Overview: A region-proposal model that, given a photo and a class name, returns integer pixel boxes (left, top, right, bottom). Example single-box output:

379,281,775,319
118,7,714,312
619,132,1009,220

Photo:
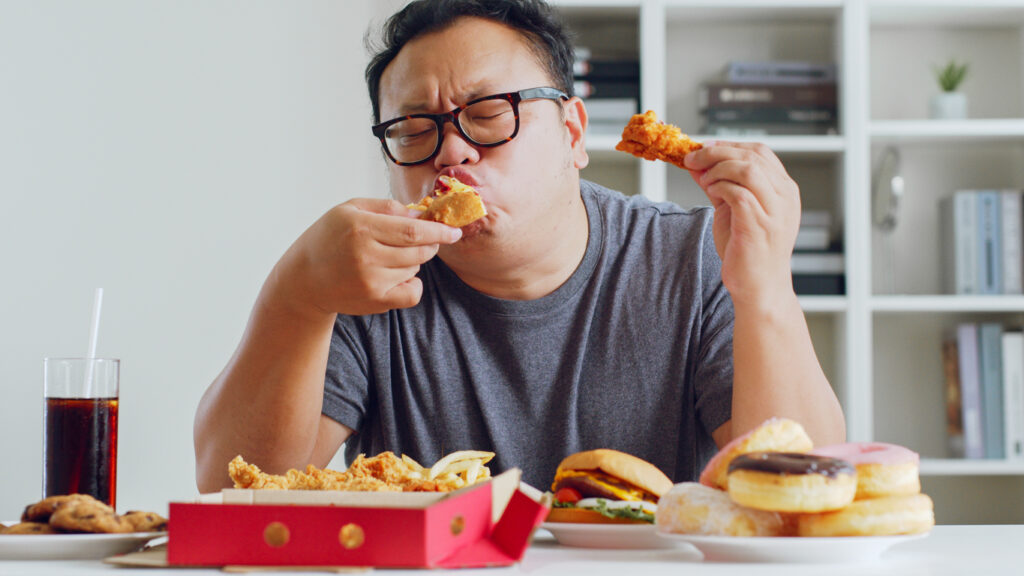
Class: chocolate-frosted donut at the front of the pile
729,452,857,512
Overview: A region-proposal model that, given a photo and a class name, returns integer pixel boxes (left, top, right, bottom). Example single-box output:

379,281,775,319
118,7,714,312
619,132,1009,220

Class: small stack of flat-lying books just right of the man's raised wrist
791,210,846,295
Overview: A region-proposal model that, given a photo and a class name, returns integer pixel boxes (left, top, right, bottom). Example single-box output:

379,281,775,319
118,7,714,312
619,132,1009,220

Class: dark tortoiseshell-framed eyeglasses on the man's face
373,87,569,166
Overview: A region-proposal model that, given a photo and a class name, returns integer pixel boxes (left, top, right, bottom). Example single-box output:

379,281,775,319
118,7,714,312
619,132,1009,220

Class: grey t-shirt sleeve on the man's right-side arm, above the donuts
695,213,735,435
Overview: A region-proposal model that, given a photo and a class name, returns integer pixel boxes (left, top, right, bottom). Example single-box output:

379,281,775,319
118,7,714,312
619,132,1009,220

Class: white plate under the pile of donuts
657,532,928,563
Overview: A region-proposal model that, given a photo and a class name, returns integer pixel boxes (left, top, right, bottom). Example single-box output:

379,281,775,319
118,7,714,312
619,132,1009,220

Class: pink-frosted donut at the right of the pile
811,442,921,500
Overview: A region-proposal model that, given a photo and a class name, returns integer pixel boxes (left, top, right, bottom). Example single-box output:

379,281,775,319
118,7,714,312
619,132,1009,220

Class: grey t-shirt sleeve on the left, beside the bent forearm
322,315,370,430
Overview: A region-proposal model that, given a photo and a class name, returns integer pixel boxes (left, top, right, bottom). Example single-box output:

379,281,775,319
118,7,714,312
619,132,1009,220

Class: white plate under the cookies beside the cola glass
0,532,167,561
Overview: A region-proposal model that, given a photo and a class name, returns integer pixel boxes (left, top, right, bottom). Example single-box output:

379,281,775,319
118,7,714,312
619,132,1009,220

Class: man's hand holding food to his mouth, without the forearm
272,199,462,315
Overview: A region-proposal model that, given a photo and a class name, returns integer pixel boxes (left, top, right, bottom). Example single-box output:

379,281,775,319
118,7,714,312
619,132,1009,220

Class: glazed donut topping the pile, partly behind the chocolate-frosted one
700,418,814,490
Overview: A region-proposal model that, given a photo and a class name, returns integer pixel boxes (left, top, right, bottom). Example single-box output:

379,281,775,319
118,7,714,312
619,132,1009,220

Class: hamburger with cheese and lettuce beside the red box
548,449,672,524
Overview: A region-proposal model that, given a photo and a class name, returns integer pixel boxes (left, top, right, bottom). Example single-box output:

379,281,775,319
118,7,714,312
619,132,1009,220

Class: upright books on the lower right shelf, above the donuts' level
942,322,1024,460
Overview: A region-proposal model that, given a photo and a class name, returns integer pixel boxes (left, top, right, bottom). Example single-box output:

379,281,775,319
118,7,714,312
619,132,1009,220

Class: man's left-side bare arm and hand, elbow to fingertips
195,199,462,492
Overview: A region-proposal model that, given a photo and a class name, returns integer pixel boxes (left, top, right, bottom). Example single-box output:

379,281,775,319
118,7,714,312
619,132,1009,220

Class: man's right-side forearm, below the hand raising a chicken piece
732,294,846,445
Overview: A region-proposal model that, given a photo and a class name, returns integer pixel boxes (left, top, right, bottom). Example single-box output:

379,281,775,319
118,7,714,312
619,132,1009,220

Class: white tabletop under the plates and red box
0,525,1024,576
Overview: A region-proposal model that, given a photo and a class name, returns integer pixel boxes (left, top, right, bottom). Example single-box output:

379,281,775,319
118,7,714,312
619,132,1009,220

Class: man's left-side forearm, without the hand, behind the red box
194,276,334,492
